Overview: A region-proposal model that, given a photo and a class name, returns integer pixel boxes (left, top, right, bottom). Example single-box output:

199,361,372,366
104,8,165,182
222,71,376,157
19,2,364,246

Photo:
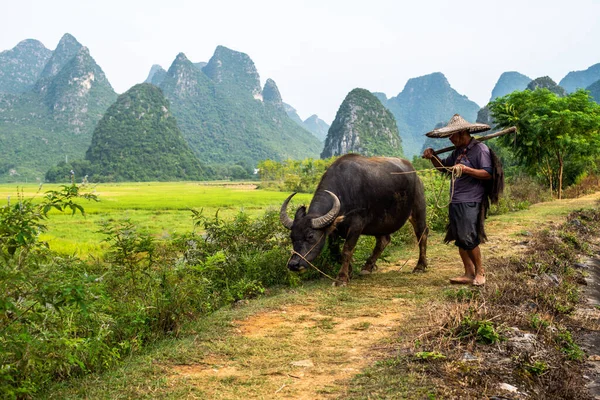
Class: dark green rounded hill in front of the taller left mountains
85,83,204,182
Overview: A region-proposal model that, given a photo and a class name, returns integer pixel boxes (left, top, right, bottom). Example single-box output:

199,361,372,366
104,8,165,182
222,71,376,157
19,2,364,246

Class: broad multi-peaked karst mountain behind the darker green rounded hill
159,46,321,167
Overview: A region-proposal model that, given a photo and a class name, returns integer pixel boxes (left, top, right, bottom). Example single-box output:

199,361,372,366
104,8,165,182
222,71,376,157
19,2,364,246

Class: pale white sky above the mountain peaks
0,0,600,124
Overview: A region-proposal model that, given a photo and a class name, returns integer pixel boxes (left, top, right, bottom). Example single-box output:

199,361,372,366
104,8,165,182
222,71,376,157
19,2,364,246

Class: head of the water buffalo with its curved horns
279,190,340,271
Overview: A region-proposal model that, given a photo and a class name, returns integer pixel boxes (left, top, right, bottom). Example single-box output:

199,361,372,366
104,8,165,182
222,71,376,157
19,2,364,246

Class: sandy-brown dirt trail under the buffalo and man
168,193,600,399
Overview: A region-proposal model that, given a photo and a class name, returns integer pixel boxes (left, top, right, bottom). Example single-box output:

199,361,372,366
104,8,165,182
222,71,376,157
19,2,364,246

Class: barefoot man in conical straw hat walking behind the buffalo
423,114,493,286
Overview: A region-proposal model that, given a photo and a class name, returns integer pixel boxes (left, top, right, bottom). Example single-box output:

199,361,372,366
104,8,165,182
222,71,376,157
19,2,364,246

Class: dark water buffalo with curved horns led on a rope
279,154,428,285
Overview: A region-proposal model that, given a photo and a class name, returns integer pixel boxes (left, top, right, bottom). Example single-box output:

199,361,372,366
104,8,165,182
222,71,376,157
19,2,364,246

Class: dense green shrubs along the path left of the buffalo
0,192,296,398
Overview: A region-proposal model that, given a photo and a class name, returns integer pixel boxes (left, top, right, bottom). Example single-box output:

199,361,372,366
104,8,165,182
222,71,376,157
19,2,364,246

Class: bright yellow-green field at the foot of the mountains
0,182,311,257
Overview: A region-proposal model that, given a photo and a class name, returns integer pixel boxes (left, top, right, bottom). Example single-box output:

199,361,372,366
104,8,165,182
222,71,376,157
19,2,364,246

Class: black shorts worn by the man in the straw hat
447,202,481,250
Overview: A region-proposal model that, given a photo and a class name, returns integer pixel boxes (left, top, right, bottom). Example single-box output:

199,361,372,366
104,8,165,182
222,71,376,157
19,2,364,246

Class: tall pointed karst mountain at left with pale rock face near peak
0,34,117,181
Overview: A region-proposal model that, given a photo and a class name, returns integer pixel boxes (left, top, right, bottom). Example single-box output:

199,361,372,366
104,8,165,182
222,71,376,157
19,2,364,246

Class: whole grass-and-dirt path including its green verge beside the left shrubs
43,193,600,400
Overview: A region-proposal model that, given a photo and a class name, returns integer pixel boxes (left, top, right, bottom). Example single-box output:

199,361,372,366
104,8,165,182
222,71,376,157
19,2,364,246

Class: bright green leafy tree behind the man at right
490,89,600,199
